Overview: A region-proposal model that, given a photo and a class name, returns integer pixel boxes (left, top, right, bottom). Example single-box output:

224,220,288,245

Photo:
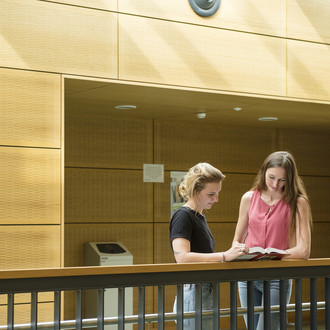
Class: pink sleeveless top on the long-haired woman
245,190,290,250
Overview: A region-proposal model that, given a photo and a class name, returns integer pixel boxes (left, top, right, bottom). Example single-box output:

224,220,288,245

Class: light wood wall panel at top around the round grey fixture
118,0,286,36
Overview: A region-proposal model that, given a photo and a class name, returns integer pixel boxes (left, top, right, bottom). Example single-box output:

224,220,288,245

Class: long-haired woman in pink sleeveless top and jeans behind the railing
233,151,312,330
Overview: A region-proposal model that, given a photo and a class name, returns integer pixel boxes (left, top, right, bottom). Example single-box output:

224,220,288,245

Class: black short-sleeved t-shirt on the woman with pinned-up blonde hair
170,206,215,253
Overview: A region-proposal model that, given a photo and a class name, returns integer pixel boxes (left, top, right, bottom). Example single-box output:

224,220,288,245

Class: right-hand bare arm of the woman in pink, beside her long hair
286,197,311,259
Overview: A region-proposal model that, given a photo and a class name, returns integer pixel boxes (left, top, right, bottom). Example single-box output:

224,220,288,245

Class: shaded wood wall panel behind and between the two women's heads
154,172,255,222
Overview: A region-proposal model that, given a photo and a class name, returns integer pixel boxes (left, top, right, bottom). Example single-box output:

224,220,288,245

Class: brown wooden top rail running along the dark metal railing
0,258,330,280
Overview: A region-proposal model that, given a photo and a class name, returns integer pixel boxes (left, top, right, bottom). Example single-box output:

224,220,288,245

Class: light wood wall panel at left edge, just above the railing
0,226,61,269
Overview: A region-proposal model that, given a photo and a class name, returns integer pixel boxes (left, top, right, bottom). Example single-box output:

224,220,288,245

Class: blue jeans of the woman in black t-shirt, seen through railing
173,283,213,330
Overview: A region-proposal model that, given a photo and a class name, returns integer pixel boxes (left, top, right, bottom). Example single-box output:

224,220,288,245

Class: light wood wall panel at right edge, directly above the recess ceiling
287,40,330,101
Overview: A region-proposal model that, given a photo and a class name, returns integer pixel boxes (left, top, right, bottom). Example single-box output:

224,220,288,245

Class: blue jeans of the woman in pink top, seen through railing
238,280,292,330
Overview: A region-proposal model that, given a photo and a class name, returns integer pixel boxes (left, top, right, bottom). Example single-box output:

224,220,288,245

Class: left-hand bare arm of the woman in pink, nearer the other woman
233,191,253,244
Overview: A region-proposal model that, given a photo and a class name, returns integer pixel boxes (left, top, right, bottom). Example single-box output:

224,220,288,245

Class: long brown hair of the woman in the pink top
252,151,312,231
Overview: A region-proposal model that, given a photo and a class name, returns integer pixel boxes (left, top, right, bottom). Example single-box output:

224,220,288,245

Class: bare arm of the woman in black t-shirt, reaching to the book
172,238,247,263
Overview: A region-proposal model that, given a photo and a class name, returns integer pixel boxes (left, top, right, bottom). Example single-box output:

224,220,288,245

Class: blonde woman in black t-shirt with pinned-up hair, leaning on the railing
170,163,248,330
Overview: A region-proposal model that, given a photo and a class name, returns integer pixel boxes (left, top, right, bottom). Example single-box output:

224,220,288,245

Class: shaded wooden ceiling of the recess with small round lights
65,78,330,132
